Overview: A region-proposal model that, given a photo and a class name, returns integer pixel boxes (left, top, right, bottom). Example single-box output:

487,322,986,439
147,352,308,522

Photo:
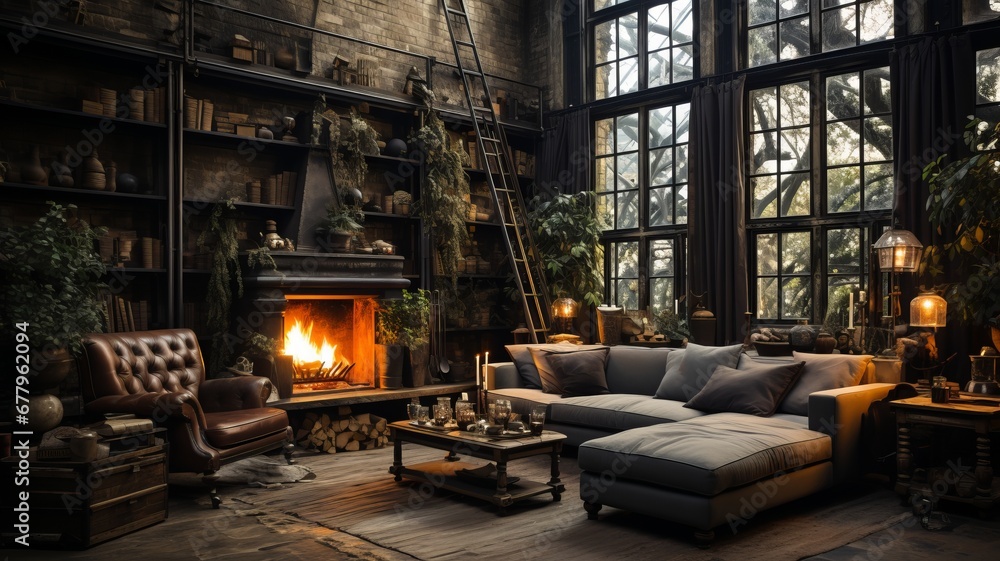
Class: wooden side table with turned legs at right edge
889,397,1000,515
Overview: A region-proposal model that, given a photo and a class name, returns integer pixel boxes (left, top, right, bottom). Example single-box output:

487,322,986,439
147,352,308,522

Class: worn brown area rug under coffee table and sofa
230,445,911,561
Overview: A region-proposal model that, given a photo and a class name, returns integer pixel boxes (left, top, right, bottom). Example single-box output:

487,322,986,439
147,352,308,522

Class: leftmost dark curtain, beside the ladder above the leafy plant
535,108,593,195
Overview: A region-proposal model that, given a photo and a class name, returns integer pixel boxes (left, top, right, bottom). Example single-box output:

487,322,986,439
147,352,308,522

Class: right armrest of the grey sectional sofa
809,384,896,482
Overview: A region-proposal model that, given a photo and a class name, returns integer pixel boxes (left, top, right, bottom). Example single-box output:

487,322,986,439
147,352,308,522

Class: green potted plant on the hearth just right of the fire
375,289,430,387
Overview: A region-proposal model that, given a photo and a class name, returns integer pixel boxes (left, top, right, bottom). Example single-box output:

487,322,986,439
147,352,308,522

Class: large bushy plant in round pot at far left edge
0,201,107,431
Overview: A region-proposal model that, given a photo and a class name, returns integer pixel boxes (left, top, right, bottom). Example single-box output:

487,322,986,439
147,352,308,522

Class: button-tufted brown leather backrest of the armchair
81,329,205,402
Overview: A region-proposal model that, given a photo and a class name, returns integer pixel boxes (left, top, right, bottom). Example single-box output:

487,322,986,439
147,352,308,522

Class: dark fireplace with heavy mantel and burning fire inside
244,252,410,399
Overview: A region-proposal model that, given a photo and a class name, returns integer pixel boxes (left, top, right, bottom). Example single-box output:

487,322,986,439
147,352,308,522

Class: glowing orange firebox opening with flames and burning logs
282,295,375,393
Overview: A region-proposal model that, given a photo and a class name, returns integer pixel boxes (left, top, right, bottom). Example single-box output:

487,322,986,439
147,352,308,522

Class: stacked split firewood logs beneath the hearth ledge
295,406,389,454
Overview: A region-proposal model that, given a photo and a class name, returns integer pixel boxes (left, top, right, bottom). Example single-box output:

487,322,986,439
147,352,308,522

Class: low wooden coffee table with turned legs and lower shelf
389,421,566,515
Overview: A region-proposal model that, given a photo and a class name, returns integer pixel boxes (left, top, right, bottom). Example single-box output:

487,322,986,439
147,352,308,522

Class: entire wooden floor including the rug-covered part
8,444,1000,561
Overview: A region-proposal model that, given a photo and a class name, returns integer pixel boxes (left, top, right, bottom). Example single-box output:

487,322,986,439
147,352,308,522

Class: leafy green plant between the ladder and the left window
528,192,604,306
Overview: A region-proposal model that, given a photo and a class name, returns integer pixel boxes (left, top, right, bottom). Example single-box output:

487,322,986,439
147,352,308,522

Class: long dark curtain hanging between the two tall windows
687,77,749,344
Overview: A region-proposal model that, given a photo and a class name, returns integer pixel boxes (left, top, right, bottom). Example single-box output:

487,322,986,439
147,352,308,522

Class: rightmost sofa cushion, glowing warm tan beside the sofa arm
778,351,872,415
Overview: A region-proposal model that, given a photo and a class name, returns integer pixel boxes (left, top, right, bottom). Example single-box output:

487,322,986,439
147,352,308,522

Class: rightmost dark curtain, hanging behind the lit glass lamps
890,35,979,382
